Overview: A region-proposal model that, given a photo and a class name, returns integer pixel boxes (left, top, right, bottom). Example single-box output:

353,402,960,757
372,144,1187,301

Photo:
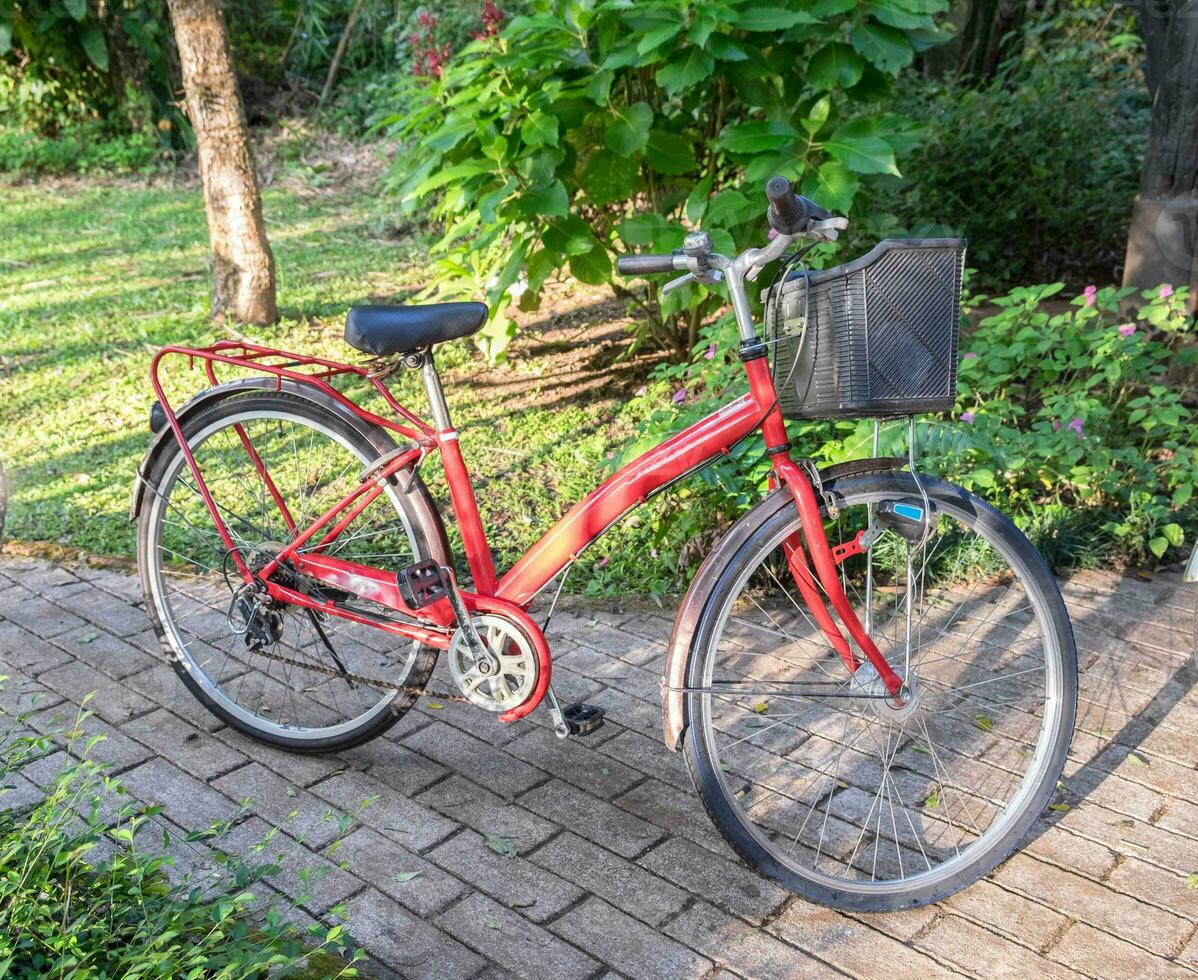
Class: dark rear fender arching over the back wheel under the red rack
129,377,450,563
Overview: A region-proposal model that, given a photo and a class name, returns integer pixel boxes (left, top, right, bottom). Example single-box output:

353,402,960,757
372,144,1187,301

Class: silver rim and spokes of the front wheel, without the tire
691,491,1065,899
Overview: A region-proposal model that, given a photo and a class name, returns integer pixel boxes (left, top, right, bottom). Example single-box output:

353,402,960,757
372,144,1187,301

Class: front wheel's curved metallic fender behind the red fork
661,456,906,752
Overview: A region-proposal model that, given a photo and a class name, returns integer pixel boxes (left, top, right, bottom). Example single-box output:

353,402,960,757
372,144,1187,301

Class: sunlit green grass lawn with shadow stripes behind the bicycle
0,182,683,592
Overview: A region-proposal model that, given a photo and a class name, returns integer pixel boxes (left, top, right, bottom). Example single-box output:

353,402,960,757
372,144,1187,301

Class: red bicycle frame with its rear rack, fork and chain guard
151,333,902,721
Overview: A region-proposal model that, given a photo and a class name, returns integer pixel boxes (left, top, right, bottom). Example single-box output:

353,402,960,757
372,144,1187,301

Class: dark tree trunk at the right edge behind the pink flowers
1124,0,1198,311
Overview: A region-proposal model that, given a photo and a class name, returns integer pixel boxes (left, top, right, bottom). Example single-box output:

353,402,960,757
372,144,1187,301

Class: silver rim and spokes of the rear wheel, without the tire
146,409,420,742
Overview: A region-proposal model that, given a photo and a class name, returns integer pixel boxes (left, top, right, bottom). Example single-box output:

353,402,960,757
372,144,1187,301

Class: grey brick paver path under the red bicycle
0,559,1198,980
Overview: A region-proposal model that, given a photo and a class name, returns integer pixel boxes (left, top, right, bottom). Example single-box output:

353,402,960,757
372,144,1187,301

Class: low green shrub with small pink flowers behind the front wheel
613,283,1198,577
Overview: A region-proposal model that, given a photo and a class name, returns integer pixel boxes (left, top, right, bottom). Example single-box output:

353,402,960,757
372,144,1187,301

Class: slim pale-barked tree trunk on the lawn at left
168,0,278,323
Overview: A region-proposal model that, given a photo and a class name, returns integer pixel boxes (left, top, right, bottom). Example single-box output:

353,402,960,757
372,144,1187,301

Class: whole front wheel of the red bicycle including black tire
684,473,1077,912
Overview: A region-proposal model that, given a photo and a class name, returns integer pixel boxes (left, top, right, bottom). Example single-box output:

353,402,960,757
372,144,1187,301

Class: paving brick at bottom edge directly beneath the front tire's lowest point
769,901,952,978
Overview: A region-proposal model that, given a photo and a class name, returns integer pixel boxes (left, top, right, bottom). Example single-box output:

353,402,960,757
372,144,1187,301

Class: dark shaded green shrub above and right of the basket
858,7,1151,289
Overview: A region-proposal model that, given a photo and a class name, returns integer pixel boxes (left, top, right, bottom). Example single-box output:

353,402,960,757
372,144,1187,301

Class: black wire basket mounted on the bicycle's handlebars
766,238,966,418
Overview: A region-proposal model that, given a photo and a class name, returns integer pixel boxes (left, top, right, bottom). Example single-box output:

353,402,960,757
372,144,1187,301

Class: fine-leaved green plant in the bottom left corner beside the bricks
0,690,361,980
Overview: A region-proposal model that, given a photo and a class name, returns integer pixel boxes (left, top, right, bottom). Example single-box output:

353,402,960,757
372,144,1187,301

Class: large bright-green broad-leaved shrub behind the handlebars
382,0,946,357
